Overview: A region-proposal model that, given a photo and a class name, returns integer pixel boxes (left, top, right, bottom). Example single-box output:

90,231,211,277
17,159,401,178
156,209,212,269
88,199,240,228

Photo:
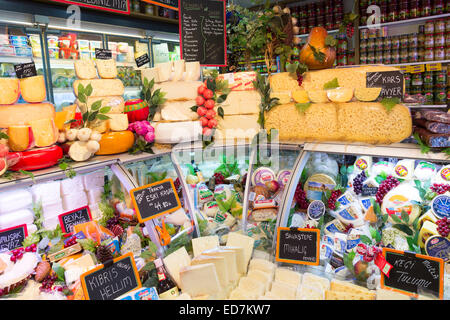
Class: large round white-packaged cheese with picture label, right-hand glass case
381,183,422,225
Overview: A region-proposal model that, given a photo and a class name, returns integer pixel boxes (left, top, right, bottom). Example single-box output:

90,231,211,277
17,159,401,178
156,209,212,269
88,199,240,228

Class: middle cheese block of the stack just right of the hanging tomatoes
215,90,261,116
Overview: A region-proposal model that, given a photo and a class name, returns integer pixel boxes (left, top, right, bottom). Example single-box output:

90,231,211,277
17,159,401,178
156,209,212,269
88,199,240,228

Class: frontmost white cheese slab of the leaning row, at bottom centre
180,263,222,299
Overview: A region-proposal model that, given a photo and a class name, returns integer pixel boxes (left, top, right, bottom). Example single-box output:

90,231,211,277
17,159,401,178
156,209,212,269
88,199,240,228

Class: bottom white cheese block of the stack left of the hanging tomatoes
152,121,202,144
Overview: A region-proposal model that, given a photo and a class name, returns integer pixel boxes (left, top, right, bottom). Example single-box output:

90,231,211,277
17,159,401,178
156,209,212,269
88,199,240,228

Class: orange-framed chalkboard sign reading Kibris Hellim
80,252,142,300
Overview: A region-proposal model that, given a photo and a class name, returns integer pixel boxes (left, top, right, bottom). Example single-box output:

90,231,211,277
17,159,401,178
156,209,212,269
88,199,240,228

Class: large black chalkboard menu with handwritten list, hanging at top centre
179,0,227,67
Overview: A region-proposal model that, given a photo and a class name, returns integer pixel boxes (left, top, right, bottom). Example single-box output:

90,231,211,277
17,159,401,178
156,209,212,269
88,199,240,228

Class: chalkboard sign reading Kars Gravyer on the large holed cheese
366,71,404,99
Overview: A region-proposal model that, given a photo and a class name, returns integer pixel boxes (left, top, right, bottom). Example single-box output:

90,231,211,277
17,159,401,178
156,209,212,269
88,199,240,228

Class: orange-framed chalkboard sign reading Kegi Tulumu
380,248,444,299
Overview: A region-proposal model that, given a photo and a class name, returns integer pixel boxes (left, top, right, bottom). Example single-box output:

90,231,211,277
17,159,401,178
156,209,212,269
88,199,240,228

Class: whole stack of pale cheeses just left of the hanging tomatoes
141,60,202,144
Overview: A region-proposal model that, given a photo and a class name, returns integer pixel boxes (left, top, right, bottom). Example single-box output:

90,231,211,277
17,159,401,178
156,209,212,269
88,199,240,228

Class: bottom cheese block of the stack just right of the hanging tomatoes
215,114,261,141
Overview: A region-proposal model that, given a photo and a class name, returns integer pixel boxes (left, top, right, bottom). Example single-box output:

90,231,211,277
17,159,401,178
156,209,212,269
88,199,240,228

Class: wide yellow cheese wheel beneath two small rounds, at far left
0,103,55,128
